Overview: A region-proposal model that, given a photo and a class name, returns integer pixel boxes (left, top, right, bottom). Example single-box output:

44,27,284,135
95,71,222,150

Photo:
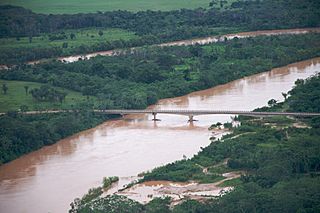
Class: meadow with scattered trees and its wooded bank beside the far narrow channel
0,28,139,64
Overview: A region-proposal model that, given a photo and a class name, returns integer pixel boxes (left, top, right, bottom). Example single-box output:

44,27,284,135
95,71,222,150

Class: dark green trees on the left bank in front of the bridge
0,110,113,165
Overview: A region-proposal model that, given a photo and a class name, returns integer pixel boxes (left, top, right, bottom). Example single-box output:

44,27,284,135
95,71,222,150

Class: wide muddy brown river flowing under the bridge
0,58,320,213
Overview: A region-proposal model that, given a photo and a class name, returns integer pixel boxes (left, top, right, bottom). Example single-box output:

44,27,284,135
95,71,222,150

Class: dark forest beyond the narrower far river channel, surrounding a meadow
0,0,320,64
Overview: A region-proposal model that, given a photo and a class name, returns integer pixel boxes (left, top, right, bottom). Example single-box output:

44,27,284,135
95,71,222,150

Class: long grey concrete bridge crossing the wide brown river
0,109,320,122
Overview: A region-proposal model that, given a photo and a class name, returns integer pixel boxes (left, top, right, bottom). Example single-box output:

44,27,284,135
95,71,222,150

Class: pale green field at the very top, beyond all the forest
0,0,211,14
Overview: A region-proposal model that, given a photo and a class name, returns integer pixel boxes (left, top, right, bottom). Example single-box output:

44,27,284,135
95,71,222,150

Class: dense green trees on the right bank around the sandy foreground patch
70,75,320,213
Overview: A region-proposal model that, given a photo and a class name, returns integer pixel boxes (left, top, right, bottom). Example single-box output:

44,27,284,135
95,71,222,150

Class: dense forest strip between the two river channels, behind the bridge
0,34,320,109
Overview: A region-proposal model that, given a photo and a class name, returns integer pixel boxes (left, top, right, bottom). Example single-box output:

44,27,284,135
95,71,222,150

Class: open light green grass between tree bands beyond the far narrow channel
0,28,138,53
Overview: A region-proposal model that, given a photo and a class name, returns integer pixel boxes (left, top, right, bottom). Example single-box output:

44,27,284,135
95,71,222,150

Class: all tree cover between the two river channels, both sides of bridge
0,34,320,163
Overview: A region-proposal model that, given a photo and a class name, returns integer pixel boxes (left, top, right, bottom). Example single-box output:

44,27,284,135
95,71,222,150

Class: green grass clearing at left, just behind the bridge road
0,80,96,112
